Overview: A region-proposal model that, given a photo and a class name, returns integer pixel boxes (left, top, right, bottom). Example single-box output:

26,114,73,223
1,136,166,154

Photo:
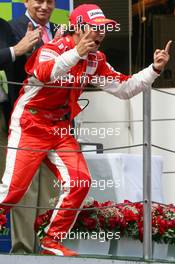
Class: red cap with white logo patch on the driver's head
70,4,118,26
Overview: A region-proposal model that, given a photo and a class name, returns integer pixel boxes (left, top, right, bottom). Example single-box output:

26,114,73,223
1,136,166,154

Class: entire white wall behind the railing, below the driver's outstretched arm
77,89,175,204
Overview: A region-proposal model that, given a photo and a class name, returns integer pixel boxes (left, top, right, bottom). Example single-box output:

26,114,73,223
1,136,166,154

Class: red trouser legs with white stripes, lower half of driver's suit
0,113,90,238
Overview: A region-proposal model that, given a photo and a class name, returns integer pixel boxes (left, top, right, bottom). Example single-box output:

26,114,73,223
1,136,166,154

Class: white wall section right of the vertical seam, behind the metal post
130,88,175,204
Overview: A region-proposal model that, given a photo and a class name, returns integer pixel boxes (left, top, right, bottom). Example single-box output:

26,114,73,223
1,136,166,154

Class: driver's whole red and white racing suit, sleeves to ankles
0,35,158,239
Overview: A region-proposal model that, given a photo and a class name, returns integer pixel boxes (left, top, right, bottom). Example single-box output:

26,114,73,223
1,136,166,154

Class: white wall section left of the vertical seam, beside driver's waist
77,91,129,153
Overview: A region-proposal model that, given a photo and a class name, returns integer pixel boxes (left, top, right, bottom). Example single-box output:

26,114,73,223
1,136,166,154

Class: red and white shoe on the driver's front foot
40,236,78,257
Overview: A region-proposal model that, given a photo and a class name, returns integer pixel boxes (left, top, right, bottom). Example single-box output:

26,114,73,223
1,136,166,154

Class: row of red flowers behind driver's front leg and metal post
35,198,175,244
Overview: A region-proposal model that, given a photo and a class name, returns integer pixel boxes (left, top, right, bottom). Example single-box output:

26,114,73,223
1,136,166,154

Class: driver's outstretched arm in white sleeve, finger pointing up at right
97,41,172,99
